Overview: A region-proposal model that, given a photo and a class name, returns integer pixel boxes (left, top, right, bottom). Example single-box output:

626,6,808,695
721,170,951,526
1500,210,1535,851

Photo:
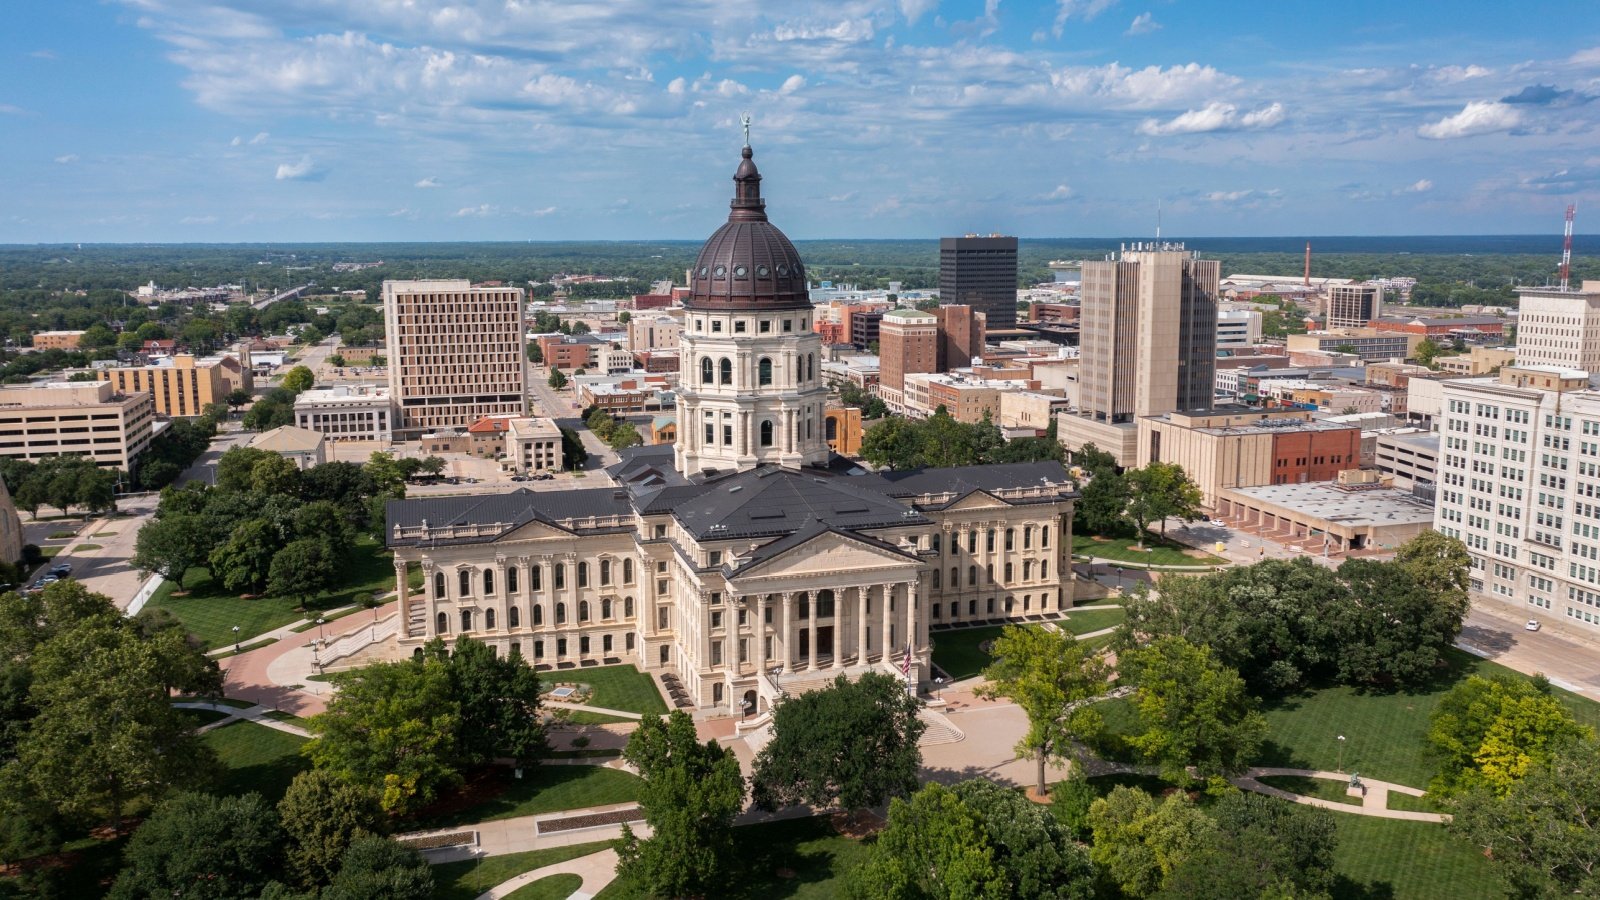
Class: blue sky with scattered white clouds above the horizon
0,0,1600,243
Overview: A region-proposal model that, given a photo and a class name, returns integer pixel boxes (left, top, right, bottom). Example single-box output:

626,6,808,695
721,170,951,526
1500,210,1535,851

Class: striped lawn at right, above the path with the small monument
1258,650,1600,788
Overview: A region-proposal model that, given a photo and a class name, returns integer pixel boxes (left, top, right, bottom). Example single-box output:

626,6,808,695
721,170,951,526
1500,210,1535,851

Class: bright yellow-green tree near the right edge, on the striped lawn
1427,674,1594,796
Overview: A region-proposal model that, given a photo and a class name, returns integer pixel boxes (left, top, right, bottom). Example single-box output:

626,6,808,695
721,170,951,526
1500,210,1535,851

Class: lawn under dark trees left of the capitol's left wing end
150,535,395,649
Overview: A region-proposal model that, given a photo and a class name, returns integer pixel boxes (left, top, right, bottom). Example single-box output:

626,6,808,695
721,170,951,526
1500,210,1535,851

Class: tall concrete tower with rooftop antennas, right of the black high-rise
1059,243,1221,466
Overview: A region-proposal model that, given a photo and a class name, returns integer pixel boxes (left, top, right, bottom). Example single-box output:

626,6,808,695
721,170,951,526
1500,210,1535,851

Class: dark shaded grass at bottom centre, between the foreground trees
595,817,869,900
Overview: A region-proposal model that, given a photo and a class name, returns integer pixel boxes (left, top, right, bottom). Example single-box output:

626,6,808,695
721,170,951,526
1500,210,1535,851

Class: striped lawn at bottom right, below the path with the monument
1333,814,1506,900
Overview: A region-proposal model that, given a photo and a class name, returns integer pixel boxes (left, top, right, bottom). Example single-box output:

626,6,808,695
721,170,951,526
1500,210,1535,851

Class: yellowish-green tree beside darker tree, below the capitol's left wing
302,650,461,814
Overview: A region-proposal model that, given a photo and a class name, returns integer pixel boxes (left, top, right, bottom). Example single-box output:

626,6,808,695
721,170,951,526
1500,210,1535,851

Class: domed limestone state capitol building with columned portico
386,146,1075,713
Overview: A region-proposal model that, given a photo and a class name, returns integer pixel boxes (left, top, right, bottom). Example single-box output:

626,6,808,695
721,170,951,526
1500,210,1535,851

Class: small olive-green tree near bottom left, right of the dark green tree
278,769,389,889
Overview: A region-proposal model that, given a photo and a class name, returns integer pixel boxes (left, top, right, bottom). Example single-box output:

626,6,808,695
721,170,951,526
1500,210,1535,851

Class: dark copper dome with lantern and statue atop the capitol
683,147,811,311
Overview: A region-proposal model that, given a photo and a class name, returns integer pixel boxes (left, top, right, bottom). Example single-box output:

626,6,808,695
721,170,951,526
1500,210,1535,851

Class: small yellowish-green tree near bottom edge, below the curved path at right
1090,786,1216,897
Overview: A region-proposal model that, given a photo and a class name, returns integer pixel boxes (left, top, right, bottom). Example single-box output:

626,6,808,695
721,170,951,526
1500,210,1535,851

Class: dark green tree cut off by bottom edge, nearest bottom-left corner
110,793,282,900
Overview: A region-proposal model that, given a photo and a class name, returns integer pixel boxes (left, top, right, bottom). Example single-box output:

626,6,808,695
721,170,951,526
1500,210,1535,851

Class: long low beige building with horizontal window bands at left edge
0,381,155,472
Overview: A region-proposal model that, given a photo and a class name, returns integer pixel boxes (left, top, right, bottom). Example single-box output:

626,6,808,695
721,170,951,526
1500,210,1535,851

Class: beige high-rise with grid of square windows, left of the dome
384,280,528,439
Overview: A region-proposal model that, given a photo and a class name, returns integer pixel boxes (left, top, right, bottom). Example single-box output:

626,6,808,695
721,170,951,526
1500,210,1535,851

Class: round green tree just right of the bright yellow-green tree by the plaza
1118,637,1267,785
